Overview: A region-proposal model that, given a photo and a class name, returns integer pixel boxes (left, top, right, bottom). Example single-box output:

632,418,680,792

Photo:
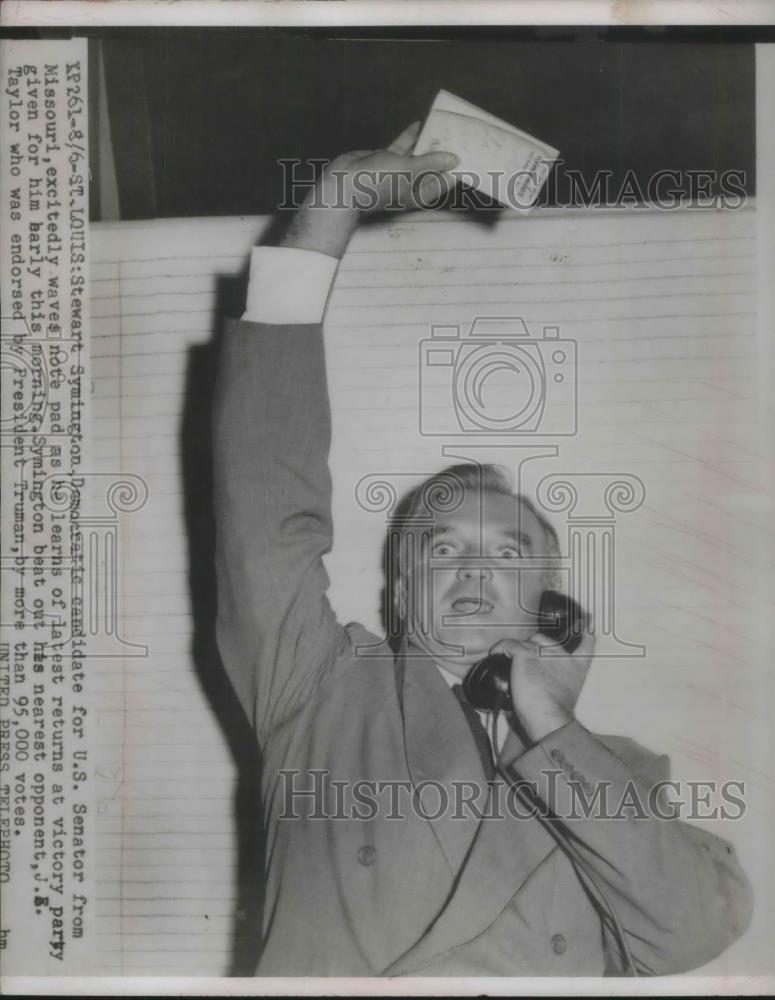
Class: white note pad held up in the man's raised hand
413,90,559,211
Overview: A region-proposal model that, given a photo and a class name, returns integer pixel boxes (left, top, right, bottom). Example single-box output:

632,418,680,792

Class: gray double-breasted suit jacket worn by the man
214,322,751,976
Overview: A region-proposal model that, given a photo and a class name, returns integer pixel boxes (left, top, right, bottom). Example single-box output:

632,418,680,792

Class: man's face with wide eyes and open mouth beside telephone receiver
407,490,550,677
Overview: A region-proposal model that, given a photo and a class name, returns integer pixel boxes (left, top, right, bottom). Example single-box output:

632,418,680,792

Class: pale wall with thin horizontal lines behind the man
91,209,775,975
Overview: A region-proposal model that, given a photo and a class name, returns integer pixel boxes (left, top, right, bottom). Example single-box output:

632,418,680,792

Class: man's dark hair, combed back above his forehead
383,462,560,633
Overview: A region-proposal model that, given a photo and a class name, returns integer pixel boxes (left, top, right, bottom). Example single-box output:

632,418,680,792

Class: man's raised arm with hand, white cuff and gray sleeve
213,130,453,742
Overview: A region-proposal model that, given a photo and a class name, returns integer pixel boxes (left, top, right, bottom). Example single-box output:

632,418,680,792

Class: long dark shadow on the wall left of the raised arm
180,262,264,976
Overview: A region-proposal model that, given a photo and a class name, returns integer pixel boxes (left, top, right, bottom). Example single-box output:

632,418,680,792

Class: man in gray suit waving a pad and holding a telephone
214,129,751,976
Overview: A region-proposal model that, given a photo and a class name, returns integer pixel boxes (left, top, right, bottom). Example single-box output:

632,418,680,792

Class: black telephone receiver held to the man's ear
463,590,587,712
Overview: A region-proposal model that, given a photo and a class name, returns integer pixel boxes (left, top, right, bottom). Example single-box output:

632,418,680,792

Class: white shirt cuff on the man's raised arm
242,247,339,324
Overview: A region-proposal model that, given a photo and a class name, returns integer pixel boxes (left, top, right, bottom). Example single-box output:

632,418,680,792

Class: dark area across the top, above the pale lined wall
94,29,755,218
